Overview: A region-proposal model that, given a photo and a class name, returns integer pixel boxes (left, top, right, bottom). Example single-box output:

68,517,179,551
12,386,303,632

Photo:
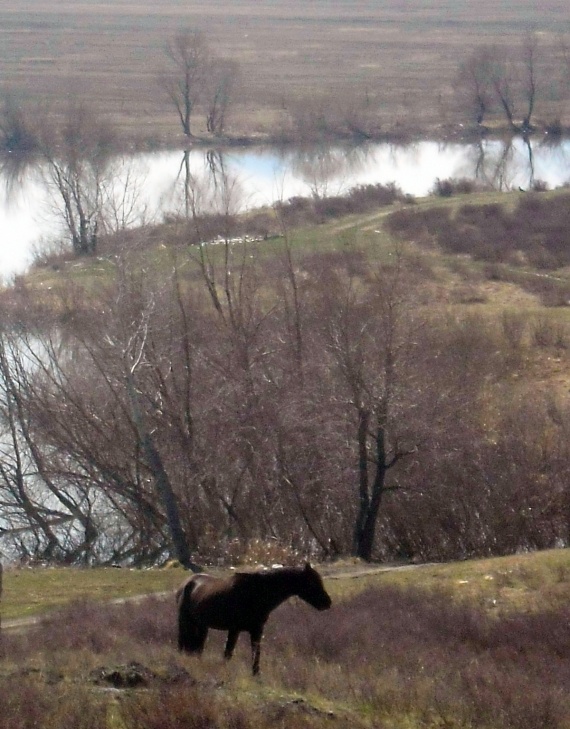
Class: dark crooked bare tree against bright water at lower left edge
0,332,98,562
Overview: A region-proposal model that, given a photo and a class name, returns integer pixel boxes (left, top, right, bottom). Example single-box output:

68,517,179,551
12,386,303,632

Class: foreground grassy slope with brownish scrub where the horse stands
0,550,570,729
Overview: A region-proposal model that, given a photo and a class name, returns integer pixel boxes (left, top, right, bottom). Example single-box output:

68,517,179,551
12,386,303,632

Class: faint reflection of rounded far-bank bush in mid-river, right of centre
282,145,370,199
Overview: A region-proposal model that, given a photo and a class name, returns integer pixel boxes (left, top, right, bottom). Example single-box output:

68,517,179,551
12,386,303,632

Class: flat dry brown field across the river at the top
0,0,570,142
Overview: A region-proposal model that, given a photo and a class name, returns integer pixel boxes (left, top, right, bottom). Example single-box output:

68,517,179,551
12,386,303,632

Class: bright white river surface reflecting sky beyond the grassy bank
0,138,570,276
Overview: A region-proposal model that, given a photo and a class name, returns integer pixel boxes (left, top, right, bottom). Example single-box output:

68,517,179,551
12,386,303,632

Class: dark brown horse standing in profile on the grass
176,563,331,675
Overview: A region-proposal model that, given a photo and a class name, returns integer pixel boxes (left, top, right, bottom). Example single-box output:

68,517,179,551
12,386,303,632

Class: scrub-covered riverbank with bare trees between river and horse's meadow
0,183,570,566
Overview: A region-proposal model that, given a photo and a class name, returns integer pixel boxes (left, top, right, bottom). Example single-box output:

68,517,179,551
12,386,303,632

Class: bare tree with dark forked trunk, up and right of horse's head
316,247,417,560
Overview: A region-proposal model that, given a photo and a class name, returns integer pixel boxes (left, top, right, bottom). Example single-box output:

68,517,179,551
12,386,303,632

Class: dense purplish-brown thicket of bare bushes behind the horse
0,237,570,563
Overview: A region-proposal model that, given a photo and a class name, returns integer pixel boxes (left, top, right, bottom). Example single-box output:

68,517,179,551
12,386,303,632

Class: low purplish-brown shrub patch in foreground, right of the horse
268,588,570,729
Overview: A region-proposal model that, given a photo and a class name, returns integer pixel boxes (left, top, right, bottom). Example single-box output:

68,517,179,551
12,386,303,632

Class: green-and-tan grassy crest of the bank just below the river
19,185,570,328
